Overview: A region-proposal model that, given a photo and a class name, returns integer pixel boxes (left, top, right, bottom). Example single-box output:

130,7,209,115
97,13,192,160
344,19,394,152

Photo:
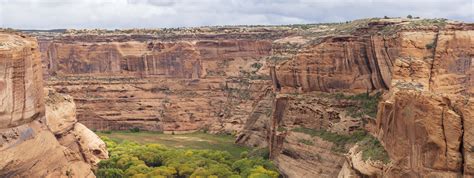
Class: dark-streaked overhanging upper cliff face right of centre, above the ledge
277,36,399,92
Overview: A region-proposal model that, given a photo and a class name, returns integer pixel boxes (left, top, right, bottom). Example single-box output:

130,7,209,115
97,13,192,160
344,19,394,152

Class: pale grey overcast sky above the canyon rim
0,0,474,29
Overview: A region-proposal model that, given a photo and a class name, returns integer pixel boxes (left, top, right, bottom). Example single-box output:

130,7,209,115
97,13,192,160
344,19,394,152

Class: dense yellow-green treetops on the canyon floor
96,137,279,178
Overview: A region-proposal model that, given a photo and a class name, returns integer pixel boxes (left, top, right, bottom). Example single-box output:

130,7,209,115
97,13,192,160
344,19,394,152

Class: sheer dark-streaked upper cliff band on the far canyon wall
42,40,271,78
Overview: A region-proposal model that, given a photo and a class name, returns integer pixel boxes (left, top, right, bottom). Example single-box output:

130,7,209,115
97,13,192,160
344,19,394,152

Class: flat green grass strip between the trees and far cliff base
96,131,249,157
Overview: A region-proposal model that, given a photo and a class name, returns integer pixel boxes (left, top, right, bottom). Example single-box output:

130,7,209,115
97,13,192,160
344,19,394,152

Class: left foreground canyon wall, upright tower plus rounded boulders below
0,33,107,177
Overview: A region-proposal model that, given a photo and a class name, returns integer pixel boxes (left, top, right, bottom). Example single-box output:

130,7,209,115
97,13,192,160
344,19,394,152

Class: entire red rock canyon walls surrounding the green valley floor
0,19,474,177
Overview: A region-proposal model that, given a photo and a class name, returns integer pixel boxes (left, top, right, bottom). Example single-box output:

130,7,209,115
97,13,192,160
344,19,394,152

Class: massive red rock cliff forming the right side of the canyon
250,20,474,177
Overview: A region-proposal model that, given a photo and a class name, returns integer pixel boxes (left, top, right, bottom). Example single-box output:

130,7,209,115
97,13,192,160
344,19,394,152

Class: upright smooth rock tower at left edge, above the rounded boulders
0,34,44,129
